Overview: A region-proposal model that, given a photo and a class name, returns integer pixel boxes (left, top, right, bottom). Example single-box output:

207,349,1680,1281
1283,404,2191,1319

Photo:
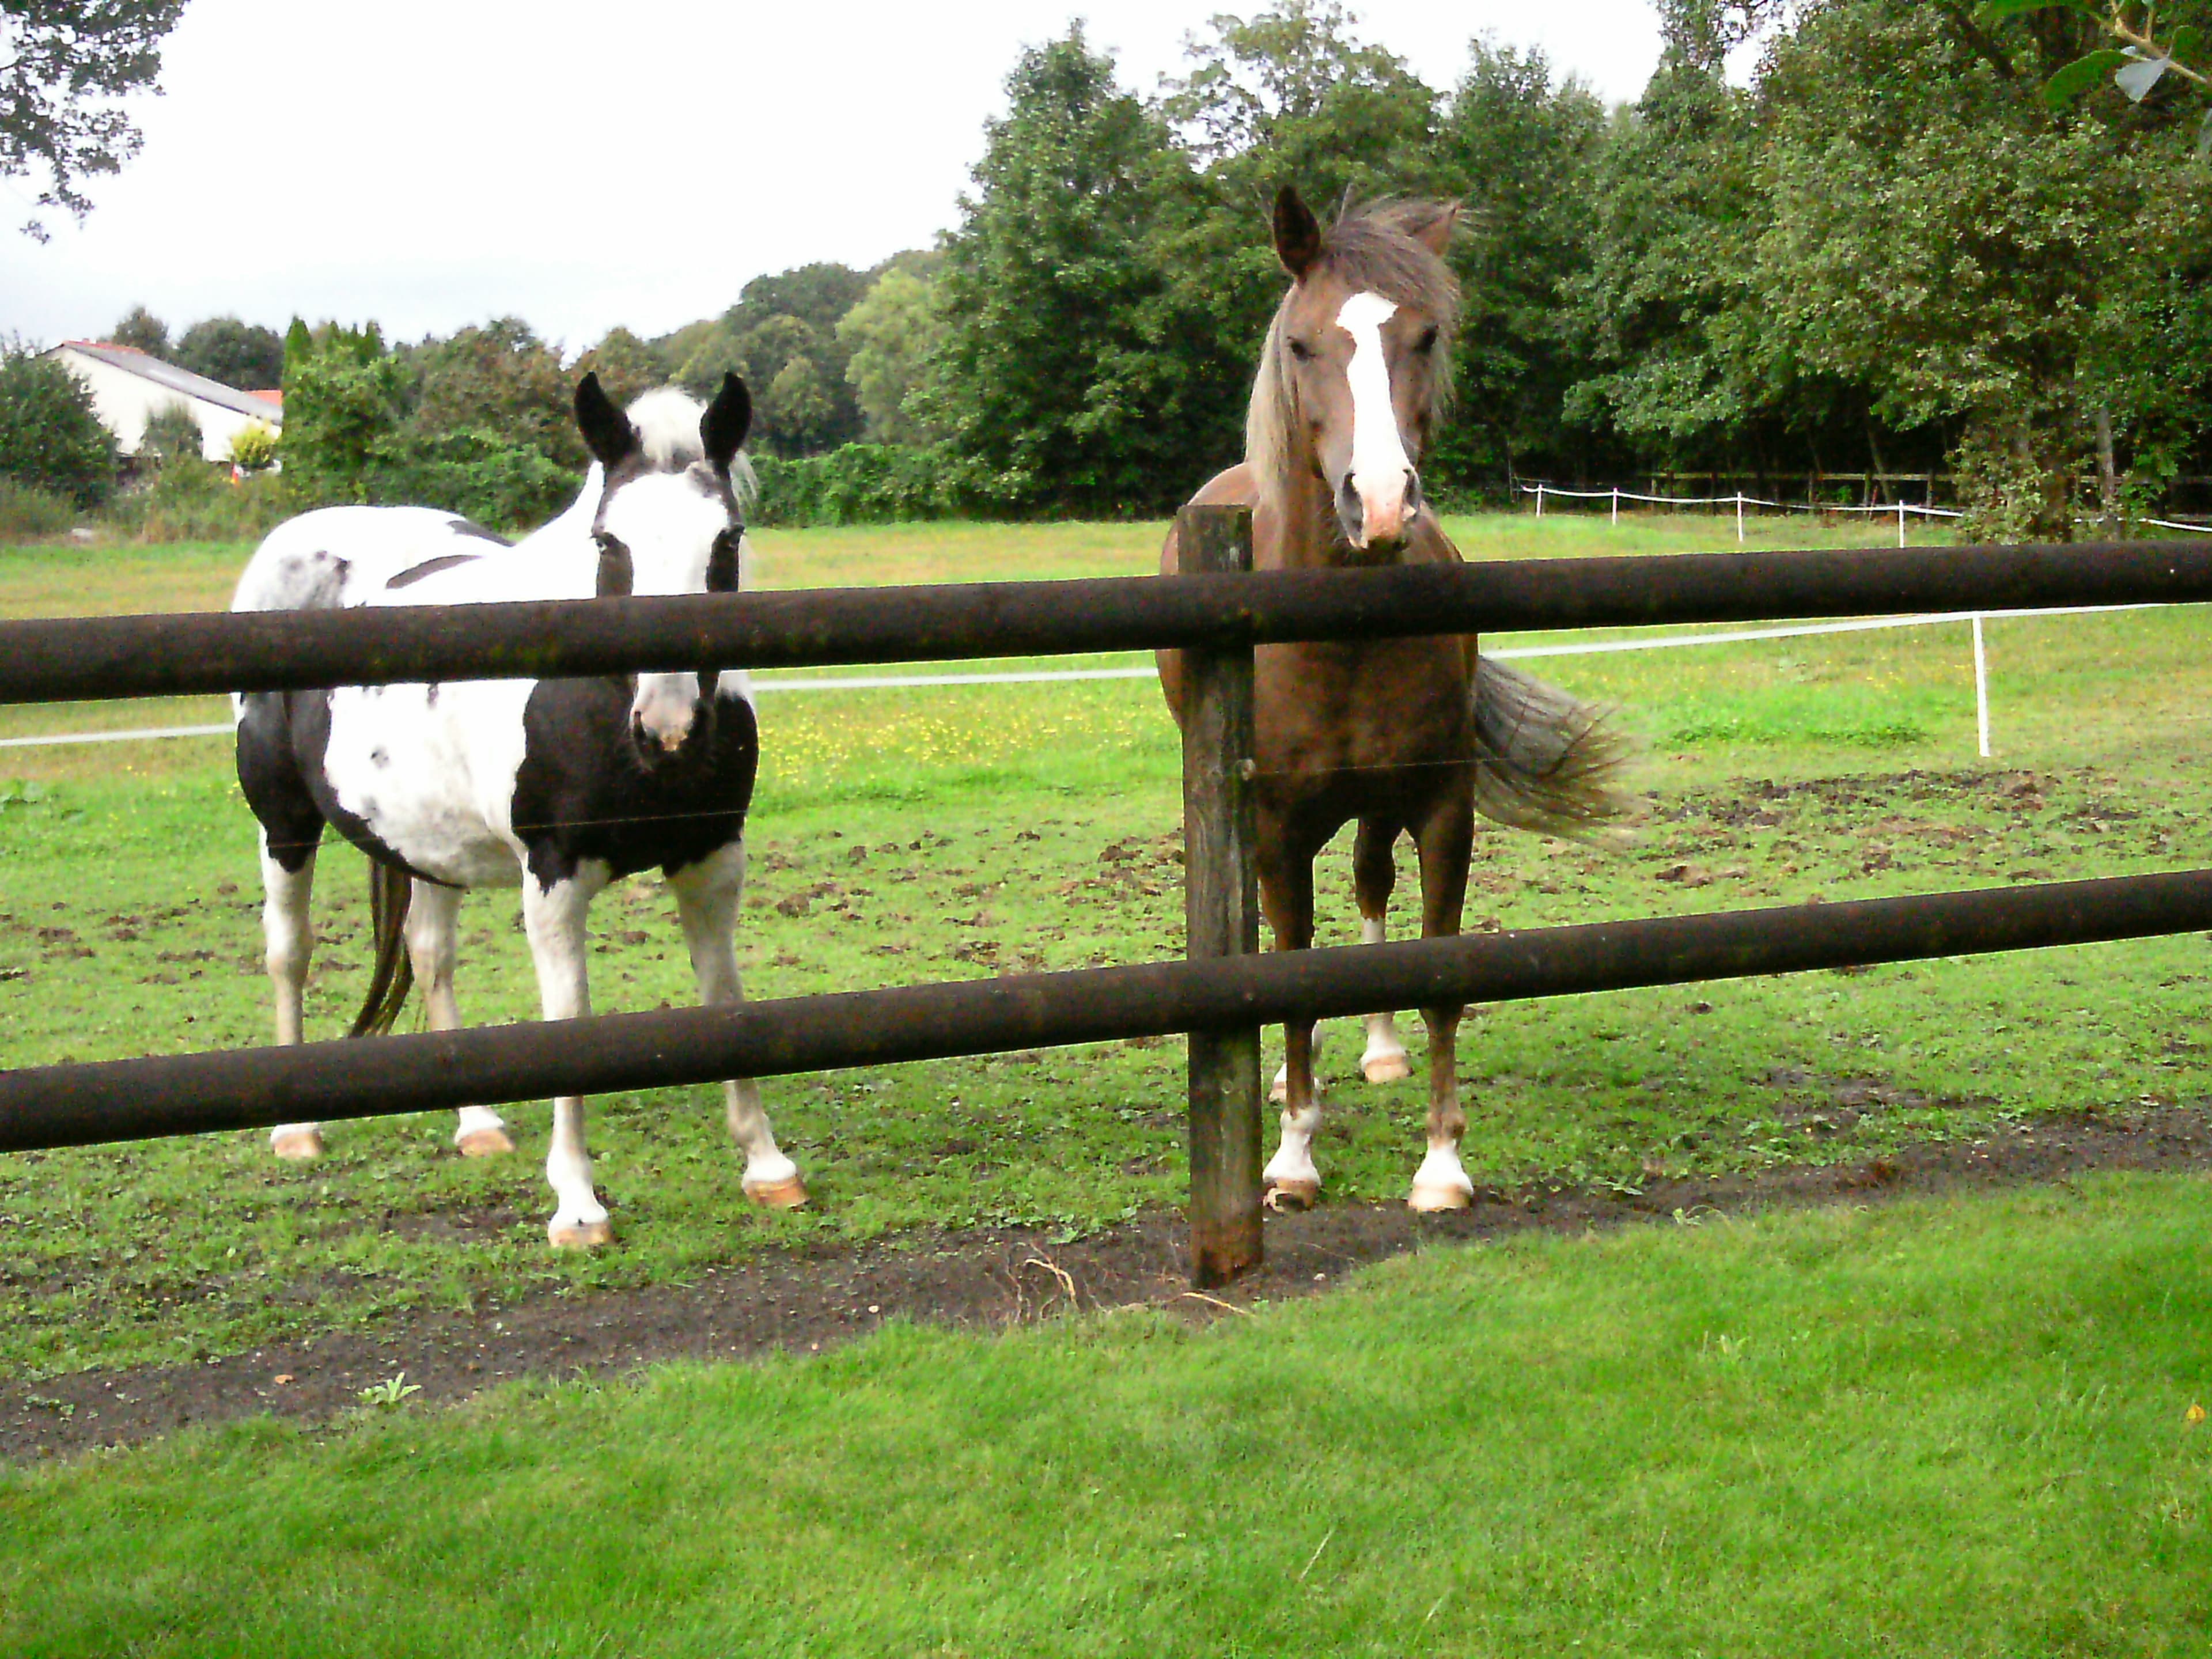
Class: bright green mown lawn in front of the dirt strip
0,1177,2212,1659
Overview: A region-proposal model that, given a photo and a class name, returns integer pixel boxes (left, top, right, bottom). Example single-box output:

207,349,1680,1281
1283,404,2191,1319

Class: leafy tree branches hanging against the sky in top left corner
0,0,184,241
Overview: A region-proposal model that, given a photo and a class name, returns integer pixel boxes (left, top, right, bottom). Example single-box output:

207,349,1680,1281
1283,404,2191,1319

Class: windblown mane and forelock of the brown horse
1245,201,1460,500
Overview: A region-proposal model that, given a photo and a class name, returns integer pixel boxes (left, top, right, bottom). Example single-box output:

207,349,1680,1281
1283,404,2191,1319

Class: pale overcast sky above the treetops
0,0,1659,352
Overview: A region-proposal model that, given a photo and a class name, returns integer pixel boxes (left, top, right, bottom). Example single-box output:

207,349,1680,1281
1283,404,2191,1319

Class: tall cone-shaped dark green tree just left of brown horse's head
922,24,1221,513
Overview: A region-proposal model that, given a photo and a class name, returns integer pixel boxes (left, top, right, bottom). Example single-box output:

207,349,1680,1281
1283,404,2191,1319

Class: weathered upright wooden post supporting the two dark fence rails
1175,506,1261,1287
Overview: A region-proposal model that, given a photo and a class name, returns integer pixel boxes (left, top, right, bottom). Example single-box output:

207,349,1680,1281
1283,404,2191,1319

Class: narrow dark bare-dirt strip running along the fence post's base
0,1106,2212,1460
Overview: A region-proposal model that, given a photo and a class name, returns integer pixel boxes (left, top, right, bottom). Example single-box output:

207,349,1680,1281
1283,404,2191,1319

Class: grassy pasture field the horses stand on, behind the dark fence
0,518,2212,1378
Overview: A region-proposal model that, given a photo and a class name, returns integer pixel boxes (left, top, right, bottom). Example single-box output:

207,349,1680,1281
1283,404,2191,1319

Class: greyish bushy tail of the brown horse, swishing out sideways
1475,657,1643,840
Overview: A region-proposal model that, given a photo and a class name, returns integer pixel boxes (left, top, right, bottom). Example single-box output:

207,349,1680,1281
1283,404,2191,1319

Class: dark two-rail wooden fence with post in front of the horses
0,528,2212,1283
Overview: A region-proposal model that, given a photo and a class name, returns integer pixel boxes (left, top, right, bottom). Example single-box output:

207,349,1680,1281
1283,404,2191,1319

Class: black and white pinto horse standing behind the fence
232,374,808,1248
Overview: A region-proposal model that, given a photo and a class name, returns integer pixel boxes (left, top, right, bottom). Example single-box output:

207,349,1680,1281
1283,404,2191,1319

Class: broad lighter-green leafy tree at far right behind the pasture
1754,0,2203,540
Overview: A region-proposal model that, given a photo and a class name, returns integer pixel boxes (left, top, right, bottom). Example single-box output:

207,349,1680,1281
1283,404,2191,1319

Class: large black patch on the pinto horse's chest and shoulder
513,679,761,889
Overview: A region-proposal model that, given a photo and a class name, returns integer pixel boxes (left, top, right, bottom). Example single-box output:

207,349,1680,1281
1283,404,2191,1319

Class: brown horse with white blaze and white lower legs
1159,188,1630,1210
